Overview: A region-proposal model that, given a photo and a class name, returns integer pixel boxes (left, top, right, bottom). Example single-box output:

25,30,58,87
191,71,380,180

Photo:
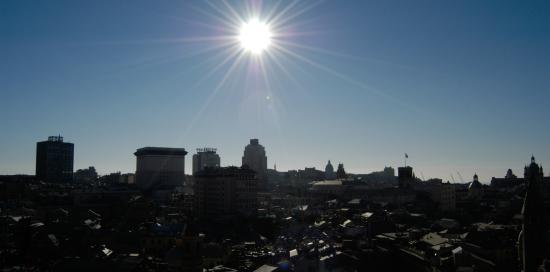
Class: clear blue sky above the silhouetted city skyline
0,0,550,182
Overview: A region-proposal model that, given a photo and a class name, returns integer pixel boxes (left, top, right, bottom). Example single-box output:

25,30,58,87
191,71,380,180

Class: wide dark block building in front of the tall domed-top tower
195,166,258,219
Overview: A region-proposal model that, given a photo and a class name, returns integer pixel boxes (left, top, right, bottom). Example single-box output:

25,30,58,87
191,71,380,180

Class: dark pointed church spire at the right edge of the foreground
518,157,548,272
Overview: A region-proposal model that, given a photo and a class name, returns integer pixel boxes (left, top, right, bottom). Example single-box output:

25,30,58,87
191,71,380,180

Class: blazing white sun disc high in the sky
239,19,272,54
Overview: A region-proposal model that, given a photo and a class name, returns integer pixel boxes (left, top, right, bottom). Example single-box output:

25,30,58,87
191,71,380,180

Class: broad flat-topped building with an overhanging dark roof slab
134,147,187,190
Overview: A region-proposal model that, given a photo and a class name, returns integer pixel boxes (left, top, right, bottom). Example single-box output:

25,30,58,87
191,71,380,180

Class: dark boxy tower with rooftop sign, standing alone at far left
36,136,74,182
